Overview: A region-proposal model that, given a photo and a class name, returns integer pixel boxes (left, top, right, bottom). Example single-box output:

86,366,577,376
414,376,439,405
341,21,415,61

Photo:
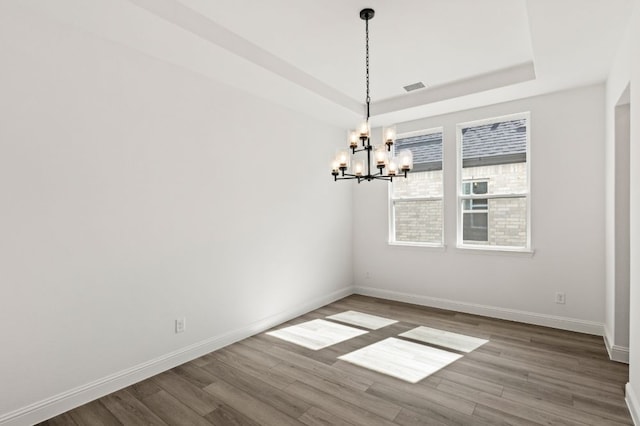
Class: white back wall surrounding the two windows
354,85,605,333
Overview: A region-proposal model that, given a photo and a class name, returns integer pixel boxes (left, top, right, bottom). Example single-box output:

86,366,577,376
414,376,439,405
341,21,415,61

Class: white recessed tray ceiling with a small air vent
10,0,633,127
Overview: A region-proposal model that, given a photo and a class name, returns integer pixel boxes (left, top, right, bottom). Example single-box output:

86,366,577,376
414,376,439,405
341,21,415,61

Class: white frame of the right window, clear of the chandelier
456,111,533,253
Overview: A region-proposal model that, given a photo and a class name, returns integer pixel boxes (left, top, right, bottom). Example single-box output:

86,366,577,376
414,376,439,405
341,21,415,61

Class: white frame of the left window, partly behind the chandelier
387,126,446,248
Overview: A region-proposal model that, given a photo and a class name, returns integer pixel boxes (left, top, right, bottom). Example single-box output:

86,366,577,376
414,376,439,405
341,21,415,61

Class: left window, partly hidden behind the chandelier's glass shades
389,129,443,246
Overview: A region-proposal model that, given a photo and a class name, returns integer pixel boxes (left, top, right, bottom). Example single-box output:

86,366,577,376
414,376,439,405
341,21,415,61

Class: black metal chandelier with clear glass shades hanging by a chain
331,9,413,183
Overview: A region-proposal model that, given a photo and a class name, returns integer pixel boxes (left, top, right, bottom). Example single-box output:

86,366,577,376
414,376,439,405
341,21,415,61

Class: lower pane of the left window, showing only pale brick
393,200,442,244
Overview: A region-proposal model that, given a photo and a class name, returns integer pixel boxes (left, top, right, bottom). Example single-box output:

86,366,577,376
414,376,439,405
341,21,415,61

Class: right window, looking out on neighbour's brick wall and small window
458,113,530,249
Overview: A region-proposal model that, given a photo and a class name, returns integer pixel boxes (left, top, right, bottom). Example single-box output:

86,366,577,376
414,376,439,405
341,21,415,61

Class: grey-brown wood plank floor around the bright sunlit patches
37,296,633,426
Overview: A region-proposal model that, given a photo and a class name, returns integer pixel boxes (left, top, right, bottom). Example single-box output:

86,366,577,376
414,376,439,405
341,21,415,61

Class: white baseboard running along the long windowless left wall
0,287,353,426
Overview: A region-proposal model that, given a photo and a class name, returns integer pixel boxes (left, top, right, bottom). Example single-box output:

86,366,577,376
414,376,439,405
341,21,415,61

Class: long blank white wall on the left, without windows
0,8,353,424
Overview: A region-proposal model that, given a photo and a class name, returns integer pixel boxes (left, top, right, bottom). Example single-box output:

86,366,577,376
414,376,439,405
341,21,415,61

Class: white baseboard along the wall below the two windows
354,287,604,336
